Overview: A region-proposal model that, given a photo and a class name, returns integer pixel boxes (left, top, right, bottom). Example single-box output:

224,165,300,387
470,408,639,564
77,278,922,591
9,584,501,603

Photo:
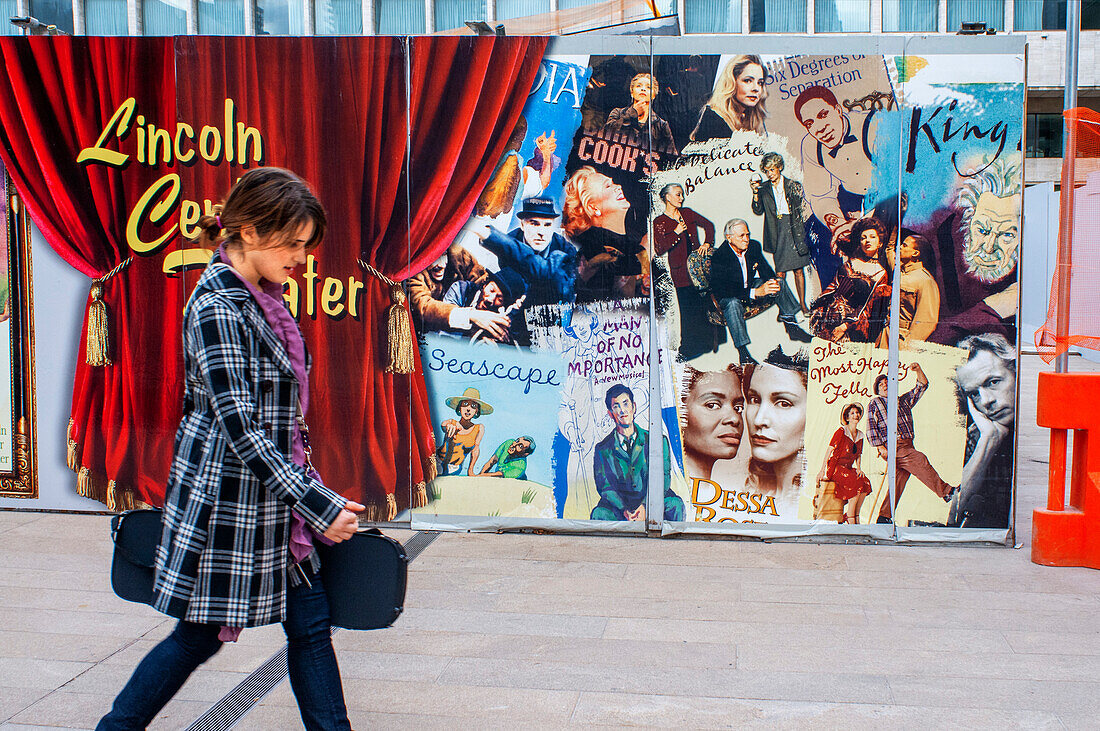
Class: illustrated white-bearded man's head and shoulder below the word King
930,158,1023,345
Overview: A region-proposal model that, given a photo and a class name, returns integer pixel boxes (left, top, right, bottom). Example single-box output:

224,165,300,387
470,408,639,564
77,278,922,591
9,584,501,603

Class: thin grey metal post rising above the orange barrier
1054,0,1081,373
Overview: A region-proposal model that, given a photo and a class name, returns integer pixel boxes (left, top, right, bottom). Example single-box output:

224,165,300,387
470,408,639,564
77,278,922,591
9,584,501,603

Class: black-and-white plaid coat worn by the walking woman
153,261,344,627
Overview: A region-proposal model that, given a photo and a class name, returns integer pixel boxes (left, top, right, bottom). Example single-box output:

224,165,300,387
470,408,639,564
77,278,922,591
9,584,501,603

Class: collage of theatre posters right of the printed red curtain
408,40,1024,534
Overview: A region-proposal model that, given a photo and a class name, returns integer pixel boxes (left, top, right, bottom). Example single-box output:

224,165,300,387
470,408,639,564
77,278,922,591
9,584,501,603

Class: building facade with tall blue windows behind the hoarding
0,0,1100,182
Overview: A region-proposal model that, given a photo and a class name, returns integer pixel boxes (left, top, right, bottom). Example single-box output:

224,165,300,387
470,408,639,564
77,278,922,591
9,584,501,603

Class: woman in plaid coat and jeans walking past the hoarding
98,168,363,730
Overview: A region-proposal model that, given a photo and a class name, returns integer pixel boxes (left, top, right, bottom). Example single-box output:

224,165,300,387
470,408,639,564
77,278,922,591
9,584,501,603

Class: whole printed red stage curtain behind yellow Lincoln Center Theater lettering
0,36,546,512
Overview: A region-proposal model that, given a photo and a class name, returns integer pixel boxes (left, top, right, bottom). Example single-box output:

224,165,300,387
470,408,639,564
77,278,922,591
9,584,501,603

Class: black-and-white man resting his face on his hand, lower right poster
948,334,1016,528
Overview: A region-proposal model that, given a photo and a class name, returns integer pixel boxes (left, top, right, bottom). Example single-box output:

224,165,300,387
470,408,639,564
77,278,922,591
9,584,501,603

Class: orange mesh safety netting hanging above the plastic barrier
1035,107,1100,363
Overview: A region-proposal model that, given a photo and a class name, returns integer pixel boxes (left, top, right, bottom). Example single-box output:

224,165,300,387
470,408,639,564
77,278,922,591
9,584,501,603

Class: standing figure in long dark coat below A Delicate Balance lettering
749,152,810,314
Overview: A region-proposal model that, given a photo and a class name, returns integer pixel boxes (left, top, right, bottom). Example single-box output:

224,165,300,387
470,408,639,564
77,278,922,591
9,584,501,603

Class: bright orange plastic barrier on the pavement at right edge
1032,373,1100,568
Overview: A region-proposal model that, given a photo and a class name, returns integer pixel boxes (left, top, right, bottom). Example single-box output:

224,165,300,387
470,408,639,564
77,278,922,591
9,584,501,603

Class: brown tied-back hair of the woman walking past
196,167,327,251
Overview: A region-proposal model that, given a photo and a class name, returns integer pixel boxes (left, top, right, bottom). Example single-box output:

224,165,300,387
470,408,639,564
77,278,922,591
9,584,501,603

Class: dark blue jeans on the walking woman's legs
96,576,351,731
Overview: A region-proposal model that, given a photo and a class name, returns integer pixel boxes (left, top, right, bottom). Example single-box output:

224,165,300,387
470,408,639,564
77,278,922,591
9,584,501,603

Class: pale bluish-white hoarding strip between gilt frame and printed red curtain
0,229,105,511
